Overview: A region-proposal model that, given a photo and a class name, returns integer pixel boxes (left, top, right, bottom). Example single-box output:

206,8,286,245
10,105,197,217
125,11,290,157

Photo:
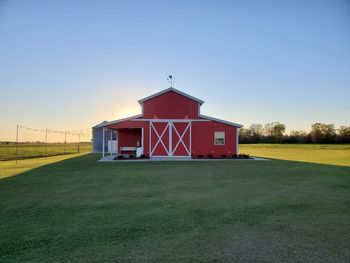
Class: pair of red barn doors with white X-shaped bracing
150,121,191,157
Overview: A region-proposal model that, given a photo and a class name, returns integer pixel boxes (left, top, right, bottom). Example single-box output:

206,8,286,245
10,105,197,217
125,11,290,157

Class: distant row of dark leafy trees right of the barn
239,122,350,143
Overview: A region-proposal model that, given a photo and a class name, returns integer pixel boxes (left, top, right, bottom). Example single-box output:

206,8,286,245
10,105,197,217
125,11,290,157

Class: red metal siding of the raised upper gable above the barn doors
143,91,199,119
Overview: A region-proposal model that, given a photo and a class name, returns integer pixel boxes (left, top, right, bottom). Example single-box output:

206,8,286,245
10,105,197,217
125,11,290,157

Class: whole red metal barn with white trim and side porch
93,88,242,158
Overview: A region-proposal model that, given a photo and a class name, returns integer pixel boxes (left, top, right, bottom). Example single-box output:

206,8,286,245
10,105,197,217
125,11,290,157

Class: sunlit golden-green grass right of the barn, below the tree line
239,144,350,166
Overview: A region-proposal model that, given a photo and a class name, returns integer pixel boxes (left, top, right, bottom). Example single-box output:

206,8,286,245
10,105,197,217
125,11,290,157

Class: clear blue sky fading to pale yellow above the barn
0,0,350,140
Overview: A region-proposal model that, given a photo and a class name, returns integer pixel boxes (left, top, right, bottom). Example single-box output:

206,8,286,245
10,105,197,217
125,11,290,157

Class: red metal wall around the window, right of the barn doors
192,121,237,157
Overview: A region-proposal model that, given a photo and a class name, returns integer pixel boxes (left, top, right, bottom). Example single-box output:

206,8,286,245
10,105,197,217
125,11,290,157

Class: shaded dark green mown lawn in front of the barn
0,154,350,262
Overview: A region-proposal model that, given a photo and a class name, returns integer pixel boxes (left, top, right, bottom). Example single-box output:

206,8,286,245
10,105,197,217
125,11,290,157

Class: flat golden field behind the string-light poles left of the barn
0,142,91,161
